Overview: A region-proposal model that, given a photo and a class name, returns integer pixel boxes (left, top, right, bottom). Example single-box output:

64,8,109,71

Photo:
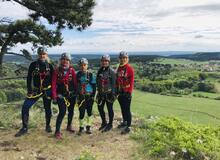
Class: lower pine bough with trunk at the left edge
0,19,63,69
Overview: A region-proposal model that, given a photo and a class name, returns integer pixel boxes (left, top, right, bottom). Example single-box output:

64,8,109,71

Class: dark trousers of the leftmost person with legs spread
21,96,52,128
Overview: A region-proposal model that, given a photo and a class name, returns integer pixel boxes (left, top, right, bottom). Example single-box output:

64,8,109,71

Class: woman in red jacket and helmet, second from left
52,53,77,139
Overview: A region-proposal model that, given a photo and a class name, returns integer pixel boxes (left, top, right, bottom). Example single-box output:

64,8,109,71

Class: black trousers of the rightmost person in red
118,94,132,127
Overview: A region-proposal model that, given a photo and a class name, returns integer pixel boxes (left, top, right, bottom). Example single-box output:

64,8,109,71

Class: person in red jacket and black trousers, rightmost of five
116,51,134,134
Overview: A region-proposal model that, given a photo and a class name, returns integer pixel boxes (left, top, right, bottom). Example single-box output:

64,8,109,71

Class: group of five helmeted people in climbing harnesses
15,47,134,139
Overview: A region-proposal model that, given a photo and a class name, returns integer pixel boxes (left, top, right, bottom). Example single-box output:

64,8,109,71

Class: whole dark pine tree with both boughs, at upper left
0,0,95,71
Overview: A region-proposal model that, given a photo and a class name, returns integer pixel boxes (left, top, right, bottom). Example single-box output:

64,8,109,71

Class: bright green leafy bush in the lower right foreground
131,117,220,160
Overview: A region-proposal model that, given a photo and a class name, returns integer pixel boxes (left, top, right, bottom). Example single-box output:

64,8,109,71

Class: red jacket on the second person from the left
52,67,77,99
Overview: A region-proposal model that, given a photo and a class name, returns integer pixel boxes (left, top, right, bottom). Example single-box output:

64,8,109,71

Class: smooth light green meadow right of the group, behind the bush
125,91,220,125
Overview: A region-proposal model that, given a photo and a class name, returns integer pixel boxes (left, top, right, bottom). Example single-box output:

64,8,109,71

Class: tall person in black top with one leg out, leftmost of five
15,47,53,137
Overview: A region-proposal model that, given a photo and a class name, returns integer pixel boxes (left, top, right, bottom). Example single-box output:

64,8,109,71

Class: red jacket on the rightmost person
116,64,134,93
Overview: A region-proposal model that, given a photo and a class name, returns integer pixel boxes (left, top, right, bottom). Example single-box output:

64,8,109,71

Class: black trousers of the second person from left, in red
56,97,76,132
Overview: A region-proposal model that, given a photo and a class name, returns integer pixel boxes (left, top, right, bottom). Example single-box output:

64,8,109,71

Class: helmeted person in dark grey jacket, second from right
96,55,116,132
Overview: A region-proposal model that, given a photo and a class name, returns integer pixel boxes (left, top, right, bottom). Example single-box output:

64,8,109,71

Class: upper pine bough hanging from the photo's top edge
3,0,95,31
